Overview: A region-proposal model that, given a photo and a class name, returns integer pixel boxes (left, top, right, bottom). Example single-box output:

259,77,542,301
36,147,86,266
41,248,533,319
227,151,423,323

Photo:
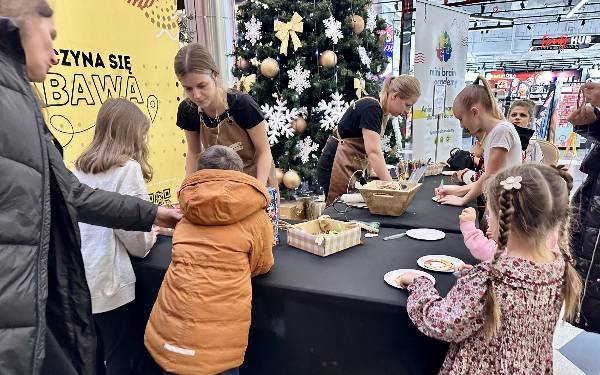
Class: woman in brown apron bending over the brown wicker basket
317,75,421,205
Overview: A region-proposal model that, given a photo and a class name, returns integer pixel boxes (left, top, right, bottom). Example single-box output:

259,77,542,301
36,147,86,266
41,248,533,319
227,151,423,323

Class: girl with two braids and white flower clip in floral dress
397,164,581,374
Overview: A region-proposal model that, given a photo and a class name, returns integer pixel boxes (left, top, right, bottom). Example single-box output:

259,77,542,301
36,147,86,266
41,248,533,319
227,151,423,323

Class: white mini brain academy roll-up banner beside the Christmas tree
412,1,469,161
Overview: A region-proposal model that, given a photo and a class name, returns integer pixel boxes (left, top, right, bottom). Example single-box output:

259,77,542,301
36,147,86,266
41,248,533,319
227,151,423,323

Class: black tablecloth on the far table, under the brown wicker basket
324,175,477,233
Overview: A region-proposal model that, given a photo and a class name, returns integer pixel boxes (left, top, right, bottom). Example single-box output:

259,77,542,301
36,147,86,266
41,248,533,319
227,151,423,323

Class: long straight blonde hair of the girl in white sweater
75,98,152,181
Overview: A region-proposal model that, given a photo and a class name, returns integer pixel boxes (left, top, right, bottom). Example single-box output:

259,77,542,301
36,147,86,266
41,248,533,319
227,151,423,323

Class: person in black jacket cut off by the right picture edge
569,83,600,333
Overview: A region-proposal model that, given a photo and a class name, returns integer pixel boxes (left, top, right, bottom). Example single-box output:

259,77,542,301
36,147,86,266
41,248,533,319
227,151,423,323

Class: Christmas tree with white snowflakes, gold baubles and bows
233,0,387,195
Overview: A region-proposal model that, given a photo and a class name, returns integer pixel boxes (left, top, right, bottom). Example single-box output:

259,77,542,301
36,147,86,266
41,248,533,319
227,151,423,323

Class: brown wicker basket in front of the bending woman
359,181,421,216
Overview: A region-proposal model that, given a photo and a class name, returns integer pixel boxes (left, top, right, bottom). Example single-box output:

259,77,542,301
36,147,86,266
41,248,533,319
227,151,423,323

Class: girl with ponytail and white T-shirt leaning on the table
436,76,521,212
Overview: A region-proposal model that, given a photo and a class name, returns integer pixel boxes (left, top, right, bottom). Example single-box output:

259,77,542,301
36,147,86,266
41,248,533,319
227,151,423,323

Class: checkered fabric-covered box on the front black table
287,219,361,257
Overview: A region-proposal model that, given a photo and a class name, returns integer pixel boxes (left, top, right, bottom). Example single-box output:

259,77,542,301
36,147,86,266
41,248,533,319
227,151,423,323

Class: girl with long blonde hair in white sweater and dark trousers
74,99,156,375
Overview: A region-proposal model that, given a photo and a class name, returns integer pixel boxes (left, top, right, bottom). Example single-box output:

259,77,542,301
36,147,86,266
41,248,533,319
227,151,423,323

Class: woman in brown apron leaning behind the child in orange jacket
175,43,278,188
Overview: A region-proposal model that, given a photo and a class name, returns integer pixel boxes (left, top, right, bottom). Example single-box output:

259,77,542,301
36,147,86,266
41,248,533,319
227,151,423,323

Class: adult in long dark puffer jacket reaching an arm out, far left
0,0,180,375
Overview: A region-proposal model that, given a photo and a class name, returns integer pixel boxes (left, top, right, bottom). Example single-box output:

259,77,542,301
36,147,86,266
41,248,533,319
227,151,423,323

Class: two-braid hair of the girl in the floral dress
484,164,582,338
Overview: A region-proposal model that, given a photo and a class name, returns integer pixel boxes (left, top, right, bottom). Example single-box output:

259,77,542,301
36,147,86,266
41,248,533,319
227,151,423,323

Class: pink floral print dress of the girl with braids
407,256,565,375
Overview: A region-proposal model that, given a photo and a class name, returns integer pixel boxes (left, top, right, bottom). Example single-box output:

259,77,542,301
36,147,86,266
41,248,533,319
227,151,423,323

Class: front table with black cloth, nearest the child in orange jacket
133,228,474,375
